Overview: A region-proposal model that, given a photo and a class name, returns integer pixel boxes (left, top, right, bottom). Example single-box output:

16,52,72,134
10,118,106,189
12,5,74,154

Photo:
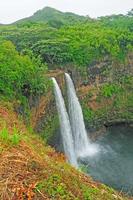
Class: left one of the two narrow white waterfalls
52,78,78,167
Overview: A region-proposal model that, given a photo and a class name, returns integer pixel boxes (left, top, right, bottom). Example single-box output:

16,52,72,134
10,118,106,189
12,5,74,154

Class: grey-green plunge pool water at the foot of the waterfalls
80,126,133,195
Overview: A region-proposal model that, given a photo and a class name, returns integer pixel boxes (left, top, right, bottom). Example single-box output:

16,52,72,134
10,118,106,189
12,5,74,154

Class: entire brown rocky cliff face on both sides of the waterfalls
31,53,133,141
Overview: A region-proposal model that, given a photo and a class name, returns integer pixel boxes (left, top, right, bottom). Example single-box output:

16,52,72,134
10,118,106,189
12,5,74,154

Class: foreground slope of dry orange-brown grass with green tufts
0,102,128,200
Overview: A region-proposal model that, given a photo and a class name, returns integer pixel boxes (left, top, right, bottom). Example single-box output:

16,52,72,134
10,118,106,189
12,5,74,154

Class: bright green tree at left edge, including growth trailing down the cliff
0,41,51,123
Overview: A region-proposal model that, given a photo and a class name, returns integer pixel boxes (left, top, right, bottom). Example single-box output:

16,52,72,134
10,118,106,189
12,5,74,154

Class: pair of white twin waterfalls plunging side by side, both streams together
52,73,95,167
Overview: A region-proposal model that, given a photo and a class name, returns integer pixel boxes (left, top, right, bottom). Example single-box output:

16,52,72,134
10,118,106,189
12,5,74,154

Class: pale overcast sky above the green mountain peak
0,0,133,23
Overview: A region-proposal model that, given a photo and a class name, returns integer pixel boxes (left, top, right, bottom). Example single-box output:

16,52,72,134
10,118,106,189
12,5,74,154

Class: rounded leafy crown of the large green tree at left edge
0,41,50,99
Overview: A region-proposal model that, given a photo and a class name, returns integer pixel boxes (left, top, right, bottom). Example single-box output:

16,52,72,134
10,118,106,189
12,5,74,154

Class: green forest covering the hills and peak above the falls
0,8,133,70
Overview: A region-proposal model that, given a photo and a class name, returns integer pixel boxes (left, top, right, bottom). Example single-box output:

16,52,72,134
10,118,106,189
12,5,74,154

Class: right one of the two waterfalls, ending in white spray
65,73,95,157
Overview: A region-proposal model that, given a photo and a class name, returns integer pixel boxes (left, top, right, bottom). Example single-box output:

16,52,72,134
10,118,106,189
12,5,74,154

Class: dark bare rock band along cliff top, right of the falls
66,52,133,88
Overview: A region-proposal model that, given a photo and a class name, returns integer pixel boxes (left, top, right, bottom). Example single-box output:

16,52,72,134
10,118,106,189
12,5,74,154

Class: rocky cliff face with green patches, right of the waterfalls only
78,53,133,127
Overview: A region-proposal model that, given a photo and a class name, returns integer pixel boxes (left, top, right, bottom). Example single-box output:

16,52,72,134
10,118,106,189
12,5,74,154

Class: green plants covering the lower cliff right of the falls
82,75,133,126
